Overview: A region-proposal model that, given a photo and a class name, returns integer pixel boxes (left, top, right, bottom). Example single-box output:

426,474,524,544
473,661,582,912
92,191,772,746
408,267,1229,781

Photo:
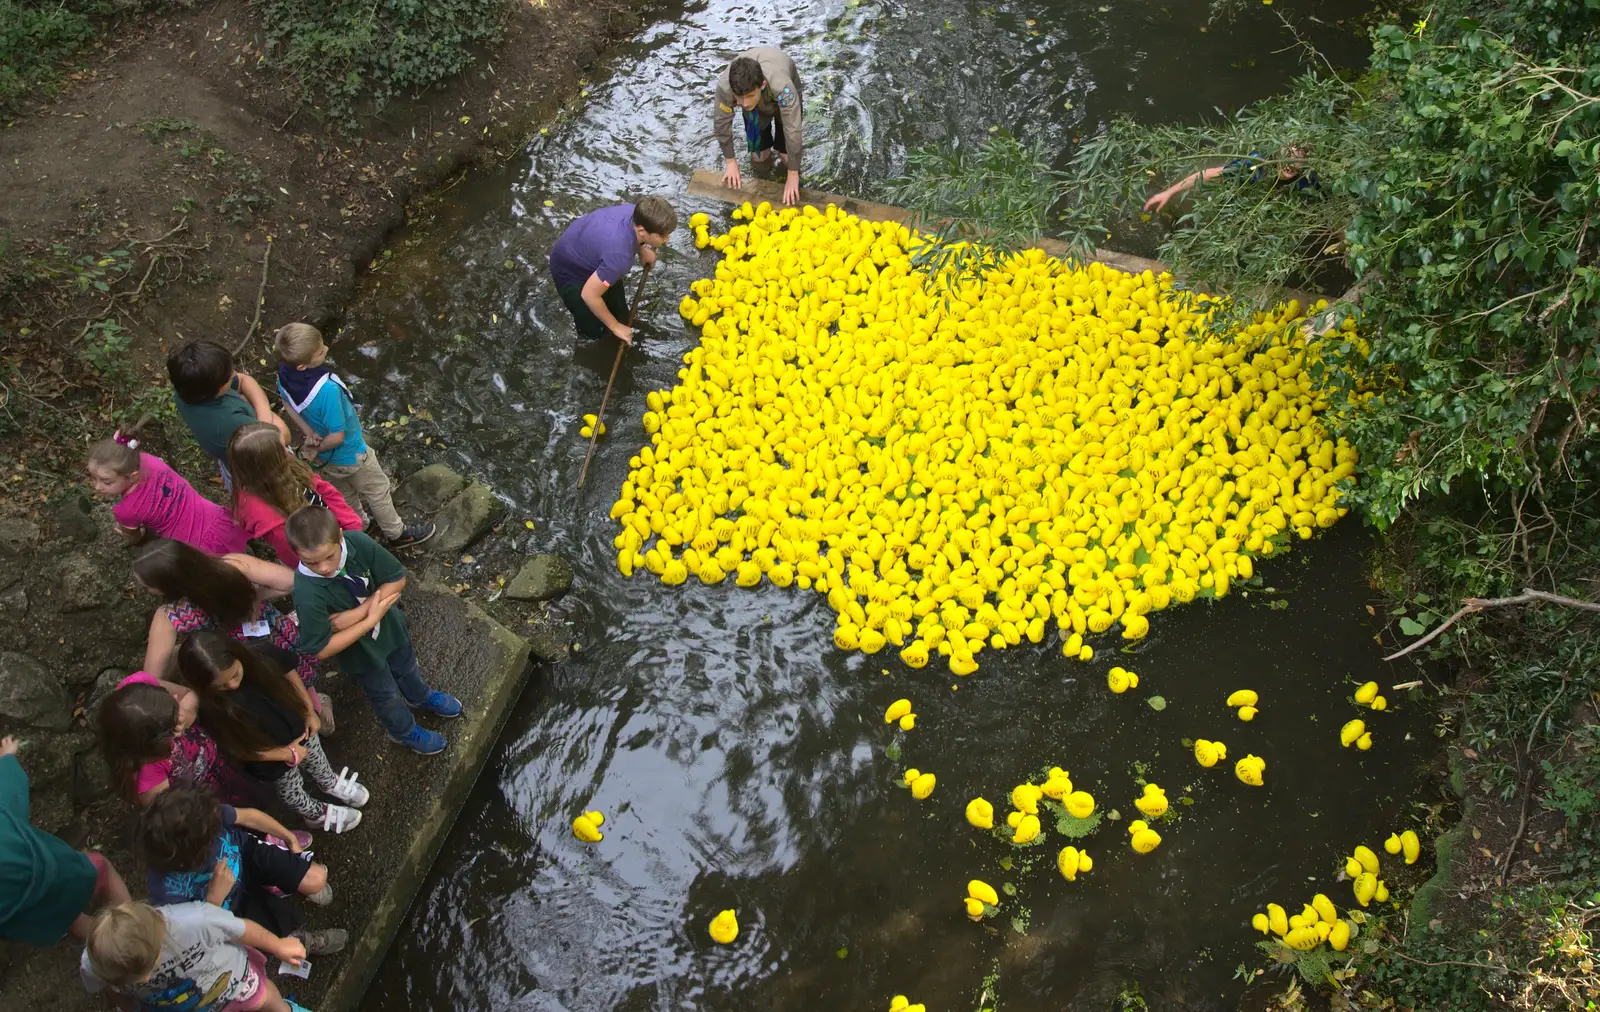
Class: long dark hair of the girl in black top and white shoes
178,629,309,762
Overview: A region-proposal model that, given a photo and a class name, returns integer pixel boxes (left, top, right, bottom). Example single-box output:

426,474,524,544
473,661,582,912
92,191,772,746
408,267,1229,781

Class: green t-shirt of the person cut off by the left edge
0,756,98,945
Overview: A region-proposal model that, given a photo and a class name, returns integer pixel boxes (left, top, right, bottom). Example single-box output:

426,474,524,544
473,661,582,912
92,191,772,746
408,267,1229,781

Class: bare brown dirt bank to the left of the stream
0,0,645,1009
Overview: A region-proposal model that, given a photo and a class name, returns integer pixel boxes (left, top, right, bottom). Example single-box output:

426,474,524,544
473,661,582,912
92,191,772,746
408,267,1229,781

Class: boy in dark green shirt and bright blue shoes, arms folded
285,506,461,756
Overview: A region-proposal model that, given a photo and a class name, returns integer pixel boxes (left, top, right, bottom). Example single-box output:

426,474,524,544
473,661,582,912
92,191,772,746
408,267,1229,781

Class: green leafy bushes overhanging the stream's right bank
894,0,1600,1009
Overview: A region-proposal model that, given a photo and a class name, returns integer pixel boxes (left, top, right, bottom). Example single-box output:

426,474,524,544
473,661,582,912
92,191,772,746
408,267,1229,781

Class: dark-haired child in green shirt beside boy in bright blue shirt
166,341,290,488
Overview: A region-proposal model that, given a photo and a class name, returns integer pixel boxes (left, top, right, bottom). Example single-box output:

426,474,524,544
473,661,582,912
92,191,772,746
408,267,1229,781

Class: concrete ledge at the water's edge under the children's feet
294,584,530,1012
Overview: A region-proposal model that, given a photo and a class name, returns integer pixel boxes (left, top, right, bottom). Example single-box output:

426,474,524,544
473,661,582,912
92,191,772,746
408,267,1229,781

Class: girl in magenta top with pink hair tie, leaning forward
86,432,246,556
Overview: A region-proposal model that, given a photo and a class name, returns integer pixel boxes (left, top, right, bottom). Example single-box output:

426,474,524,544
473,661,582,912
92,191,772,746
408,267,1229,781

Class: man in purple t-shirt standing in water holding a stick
550,197,678,344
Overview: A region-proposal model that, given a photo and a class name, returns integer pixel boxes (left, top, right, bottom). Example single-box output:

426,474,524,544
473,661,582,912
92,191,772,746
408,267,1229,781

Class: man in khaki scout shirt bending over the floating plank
712,46,805,203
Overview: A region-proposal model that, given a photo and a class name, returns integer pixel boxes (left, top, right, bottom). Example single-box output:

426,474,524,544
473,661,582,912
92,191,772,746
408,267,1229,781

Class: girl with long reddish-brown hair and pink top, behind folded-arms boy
227,421,363,568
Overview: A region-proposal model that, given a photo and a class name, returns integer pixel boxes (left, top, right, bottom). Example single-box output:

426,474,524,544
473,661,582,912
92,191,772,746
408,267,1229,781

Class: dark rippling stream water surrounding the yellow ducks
344,0,1432,1012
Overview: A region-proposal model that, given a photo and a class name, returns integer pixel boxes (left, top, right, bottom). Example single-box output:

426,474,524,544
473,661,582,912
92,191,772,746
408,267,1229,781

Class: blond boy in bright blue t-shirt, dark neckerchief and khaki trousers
272,323,437,549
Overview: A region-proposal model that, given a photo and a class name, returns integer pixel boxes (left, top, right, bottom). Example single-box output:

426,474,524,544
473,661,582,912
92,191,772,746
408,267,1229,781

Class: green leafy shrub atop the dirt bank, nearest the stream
256,0,507,125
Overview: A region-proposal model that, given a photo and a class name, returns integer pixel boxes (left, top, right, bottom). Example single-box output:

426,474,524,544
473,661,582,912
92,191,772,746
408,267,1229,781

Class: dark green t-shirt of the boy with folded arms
294,530,411,674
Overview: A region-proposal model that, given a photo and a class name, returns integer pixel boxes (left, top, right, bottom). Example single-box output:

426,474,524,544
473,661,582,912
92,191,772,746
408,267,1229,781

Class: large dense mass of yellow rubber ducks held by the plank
611,203,1357,674
